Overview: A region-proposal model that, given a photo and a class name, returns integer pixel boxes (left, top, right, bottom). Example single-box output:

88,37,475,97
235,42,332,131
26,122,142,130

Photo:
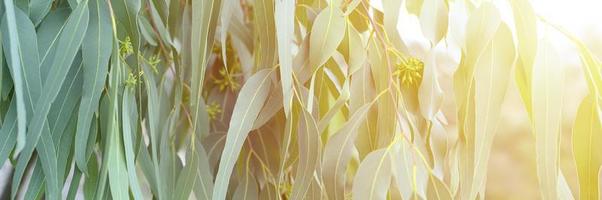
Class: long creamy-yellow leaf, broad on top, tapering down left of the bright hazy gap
471,24,516,197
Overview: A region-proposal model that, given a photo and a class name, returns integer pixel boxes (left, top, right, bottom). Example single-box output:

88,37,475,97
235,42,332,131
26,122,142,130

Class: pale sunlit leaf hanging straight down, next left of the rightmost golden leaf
531,31,564,199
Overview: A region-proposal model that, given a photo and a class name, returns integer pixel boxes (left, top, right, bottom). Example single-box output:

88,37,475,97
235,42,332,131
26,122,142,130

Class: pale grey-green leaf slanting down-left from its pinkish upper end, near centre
212,69,273,200
